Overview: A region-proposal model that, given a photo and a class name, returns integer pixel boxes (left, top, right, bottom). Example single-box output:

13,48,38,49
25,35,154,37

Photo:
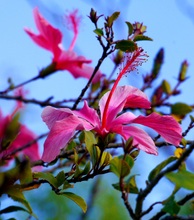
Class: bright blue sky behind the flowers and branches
0,0,194,218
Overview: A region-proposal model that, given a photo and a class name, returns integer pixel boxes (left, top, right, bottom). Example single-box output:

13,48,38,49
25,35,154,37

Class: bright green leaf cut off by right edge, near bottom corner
165,170,194,190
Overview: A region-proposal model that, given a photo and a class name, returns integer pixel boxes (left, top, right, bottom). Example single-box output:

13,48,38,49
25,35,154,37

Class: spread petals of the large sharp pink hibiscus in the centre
42,86,182,162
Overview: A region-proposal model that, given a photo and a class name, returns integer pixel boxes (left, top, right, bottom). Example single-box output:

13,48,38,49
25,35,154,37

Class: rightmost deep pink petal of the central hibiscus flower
133,112,182,146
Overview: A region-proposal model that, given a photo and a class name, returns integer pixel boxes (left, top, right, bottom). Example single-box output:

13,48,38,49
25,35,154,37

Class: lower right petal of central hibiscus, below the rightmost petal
121,126,158,155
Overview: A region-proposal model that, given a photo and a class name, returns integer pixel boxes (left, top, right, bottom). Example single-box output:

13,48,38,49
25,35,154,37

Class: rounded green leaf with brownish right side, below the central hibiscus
110,157,131,178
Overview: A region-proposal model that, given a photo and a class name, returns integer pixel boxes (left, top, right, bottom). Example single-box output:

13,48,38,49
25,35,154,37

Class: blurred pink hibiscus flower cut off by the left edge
0,89,40,162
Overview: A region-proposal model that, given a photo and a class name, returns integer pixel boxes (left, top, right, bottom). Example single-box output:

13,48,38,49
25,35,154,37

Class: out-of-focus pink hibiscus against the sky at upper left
24,8,102,83
